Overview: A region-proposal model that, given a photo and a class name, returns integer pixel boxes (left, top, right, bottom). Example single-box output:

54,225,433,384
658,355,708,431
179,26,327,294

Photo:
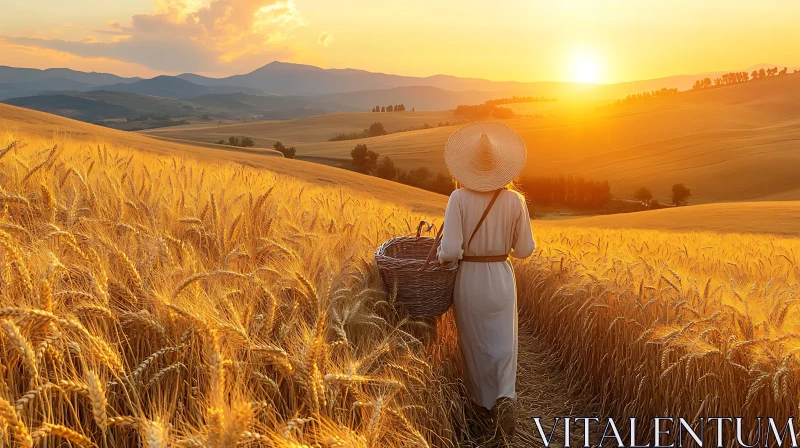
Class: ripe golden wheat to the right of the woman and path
517,226,800,432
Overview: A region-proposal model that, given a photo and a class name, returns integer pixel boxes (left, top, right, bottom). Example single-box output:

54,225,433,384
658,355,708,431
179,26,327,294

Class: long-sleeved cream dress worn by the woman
438,188,536,409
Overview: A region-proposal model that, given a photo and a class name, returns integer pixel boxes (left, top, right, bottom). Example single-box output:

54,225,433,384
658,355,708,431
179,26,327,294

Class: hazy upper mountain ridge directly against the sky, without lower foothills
0,62,792,99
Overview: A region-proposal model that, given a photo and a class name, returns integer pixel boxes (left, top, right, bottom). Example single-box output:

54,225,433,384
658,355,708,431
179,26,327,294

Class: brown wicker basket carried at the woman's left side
375,221,458,317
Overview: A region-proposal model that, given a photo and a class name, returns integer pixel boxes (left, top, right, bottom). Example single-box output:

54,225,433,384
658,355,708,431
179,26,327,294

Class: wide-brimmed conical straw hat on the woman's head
444,121,528,191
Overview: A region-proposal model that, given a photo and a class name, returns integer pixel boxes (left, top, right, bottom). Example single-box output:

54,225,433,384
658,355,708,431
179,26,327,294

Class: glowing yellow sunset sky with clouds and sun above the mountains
0,0,800,83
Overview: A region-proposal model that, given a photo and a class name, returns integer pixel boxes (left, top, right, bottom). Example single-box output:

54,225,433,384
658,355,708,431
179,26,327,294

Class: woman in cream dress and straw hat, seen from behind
438,122,536,436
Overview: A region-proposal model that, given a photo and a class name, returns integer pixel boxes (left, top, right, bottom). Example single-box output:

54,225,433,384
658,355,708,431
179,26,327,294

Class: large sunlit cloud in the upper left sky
0,0,310,73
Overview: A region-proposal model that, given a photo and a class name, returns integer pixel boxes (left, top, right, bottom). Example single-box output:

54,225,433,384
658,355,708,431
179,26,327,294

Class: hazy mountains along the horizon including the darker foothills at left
0,62,796,124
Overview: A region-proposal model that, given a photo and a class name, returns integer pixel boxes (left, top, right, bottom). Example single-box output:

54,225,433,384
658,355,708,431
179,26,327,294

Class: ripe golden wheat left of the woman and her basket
0,128,472,447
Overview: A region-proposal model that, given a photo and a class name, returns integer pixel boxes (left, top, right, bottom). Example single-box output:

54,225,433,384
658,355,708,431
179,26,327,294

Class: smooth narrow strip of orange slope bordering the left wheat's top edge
0,104,447,217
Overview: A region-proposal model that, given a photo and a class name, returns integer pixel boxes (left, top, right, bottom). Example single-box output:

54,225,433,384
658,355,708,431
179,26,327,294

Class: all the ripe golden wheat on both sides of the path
0,107,800,447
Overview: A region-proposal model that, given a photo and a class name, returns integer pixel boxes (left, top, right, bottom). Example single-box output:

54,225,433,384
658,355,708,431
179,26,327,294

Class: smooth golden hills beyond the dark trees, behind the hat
150,75,800,203
